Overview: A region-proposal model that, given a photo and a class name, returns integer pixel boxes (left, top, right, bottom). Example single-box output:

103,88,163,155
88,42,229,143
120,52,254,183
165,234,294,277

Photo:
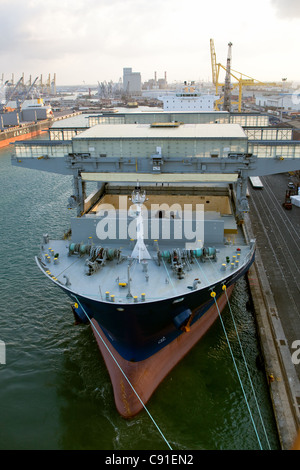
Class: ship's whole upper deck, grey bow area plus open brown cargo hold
37,184,253,305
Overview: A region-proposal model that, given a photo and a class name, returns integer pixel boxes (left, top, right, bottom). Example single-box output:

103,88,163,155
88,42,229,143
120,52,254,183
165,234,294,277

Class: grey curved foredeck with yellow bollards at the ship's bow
39,235,251,304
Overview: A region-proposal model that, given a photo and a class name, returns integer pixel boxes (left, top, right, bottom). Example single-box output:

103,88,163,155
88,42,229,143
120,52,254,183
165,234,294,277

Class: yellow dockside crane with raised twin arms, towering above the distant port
210,39,277,113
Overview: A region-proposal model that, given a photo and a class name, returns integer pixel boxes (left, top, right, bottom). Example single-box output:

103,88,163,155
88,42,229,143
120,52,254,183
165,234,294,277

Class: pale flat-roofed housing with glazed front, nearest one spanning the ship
73,124,247,159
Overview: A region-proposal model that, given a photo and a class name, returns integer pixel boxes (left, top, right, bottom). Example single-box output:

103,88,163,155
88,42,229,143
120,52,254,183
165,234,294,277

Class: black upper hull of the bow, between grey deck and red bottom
52,253,254,362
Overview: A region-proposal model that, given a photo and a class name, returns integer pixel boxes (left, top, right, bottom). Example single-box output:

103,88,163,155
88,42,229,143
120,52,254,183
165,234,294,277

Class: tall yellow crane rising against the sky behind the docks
210,39,277,113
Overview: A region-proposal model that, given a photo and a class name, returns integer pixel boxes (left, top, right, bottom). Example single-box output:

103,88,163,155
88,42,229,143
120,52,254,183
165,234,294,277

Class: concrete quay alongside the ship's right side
245,174,300,450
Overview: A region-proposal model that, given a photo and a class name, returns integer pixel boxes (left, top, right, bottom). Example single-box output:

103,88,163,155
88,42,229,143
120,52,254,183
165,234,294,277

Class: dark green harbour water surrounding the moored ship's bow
0,141,279,451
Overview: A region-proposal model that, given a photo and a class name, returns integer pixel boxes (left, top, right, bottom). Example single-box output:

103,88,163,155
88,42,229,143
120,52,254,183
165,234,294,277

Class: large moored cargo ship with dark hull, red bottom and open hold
36,185,255,417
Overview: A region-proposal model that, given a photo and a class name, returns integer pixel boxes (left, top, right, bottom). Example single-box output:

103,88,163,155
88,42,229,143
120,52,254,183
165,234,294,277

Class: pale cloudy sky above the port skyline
0,0,300,86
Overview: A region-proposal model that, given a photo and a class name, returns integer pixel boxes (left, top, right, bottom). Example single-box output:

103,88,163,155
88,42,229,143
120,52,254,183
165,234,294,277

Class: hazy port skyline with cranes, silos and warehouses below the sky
0,39,300,146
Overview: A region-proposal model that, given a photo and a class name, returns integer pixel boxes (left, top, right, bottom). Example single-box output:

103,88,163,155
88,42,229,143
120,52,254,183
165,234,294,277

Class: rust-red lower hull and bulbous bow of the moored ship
92,286,233,418
